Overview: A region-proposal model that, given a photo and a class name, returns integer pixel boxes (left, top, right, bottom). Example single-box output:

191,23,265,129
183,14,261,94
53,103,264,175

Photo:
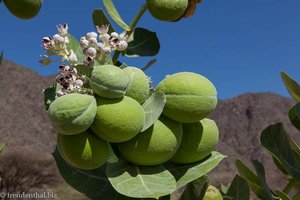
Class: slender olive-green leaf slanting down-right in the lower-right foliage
235,160,264,198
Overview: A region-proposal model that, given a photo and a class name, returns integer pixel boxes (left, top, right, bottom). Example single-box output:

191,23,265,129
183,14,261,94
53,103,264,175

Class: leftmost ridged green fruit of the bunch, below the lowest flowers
48,93,97,135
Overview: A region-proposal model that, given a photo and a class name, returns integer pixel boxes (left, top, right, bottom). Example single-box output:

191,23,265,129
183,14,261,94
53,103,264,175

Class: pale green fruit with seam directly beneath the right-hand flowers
90,65,129,99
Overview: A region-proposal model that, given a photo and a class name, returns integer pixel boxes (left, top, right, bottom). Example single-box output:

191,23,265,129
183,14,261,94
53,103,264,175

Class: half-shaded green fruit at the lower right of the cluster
171,119,219,164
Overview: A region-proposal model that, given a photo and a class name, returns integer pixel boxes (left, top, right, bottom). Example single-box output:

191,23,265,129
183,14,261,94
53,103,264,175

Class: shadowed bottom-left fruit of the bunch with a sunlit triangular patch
57,130,109,170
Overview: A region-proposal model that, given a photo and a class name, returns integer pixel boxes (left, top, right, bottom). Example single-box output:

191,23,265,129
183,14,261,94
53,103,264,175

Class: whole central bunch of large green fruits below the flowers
48,65,219,170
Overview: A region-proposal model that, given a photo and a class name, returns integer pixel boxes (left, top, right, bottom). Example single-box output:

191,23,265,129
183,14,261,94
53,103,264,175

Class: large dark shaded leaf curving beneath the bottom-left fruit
53,148,132,200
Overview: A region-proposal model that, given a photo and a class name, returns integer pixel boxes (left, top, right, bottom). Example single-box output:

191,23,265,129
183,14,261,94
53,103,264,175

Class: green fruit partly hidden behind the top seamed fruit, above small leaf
123,67,149,104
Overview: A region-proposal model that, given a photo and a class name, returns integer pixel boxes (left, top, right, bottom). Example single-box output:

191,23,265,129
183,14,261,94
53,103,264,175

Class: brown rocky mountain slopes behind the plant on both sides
0,61,300,198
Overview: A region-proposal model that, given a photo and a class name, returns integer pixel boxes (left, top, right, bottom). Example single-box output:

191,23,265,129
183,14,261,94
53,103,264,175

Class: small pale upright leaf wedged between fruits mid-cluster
141,91,166,132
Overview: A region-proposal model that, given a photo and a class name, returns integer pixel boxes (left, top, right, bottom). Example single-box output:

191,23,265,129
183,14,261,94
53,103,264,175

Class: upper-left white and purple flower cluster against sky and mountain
40,24,78,65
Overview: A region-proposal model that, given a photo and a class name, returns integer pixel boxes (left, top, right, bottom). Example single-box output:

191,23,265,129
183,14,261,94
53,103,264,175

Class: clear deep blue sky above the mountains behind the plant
0,0,300,99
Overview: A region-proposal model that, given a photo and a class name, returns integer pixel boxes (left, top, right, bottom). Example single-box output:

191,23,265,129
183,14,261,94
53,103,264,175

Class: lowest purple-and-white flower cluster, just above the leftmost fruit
56,65,83,96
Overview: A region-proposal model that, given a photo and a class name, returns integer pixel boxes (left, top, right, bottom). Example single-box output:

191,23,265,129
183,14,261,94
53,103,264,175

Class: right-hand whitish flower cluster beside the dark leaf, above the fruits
80,25,128,65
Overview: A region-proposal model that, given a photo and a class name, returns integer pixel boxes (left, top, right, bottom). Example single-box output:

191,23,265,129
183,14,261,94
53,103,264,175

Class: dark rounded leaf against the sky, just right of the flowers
126,28,160,57
